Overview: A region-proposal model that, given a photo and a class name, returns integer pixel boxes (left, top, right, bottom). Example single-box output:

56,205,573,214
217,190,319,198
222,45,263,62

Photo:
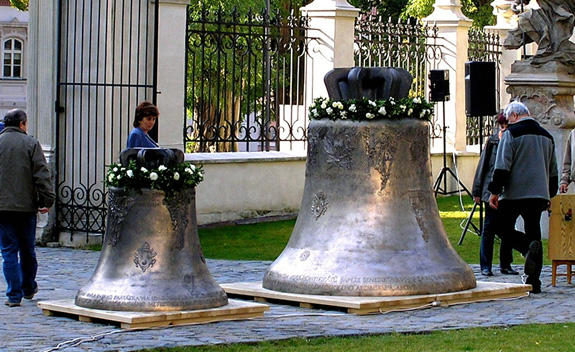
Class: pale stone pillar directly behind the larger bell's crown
301,0,359,102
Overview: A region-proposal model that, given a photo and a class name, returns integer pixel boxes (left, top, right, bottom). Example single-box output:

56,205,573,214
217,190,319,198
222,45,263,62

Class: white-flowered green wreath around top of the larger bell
309,97,433,121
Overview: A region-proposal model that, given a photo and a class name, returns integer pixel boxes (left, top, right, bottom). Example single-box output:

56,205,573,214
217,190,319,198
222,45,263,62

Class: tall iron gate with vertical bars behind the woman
55,0,159,240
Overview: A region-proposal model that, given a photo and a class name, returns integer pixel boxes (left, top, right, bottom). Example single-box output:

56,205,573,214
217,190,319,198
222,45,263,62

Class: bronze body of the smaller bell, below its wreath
75,188,228,311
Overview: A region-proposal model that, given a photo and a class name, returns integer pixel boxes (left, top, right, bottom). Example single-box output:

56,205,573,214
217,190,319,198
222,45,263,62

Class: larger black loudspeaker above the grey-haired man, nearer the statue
465,61,497,116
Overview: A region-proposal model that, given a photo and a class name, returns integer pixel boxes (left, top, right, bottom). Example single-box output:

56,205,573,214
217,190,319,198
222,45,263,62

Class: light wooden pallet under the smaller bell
38,299,270,329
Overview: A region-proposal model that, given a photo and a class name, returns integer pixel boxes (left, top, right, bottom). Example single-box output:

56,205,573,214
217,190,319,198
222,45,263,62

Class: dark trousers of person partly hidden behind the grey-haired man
479,203,515,270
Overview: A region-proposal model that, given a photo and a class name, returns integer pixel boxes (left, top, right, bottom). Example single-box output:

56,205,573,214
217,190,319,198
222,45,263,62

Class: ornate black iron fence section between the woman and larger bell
184,7,310,152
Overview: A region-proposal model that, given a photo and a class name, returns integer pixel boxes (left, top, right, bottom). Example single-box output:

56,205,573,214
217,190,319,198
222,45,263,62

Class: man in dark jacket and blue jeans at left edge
0,109,56,307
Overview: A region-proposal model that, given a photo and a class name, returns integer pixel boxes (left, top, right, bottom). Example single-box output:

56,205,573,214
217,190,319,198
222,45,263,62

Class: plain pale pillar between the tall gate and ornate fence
154,0,190,150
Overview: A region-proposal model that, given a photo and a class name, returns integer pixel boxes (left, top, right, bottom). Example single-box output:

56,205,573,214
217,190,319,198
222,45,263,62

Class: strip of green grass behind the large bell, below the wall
199,196,550,268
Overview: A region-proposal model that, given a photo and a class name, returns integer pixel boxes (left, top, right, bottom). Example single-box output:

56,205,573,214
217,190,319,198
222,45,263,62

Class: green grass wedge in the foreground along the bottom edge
142,323,575,352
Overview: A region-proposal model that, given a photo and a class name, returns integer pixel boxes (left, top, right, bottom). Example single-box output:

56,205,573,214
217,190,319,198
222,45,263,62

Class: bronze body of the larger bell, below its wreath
263,119,476,296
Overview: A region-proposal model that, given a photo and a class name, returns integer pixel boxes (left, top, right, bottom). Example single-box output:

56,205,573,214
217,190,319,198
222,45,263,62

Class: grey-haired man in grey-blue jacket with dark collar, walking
488,102,559,293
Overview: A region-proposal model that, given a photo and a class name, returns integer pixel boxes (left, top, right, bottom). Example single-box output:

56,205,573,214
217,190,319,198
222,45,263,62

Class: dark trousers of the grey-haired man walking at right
497,199,549,285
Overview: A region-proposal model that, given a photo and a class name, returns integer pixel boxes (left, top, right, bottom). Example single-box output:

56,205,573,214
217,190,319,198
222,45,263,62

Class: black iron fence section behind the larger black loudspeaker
466,28,502,145
